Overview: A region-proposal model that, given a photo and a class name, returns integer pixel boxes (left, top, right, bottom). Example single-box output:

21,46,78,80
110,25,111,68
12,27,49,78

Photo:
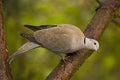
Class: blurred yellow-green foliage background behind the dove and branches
3,0,120,80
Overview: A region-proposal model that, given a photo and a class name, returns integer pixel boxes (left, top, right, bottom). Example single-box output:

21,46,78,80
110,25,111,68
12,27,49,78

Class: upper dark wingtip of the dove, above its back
24,25,57,31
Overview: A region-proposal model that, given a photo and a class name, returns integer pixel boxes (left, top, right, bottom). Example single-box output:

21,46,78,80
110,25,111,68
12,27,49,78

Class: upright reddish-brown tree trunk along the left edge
0,0,12,80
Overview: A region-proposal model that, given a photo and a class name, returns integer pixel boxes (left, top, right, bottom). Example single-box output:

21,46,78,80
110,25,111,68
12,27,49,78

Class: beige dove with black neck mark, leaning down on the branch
8,24,99,63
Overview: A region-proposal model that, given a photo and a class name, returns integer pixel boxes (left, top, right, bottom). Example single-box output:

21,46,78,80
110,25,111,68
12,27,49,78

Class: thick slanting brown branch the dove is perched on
46,0,120,80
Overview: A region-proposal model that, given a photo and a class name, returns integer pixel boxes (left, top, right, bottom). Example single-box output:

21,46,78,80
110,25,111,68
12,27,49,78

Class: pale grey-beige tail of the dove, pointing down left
7,42,40,64
